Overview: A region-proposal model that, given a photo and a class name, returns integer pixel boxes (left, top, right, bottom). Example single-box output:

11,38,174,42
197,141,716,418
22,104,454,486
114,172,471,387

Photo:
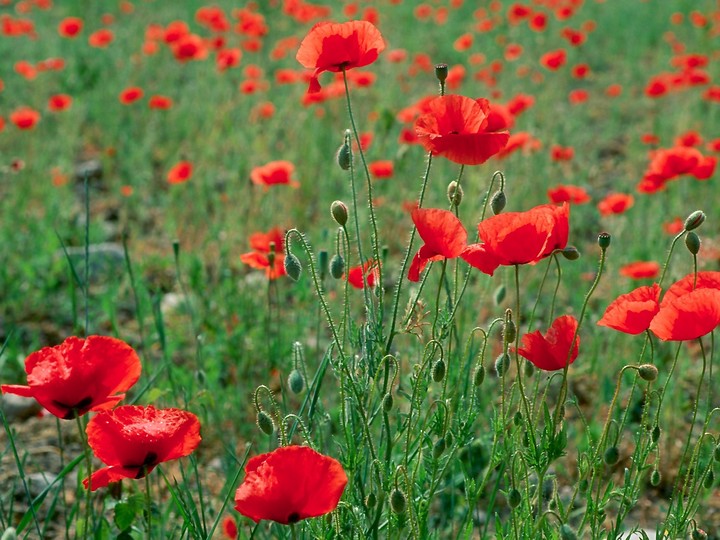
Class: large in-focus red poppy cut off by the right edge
650,272,720,341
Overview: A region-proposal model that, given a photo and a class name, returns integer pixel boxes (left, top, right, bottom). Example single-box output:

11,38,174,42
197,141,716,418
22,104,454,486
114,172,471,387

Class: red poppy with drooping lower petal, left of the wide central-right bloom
408,208,467,281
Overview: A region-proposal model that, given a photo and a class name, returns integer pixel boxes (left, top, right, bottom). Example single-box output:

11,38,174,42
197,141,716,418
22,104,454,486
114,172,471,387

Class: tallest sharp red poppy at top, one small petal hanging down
295,21,385,93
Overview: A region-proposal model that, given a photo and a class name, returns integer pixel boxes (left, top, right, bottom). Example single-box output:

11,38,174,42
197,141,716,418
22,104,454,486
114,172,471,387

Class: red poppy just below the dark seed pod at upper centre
415,95,510,165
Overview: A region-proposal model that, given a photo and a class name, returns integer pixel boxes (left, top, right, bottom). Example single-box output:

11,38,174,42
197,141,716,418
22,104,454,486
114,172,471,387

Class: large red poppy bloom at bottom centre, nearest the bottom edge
235,446,347,525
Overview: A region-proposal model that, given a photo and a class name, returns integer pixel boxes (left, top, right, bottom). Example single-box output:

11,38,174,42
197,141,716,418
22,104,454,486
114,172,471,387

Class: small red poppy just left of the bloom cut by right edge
597,283,660,335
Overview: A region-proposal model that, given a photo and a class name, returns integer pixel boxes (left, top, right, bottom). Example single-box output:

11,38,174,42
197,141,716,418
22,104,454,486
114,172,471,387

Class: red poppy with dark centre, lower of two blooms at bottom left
83,405,200,491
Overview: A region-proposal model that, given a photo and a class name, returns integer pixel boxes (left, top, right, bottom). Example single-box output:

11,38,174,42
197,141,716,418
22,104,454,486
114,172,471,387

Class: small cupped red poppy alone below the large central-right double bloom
518,315,580,371
